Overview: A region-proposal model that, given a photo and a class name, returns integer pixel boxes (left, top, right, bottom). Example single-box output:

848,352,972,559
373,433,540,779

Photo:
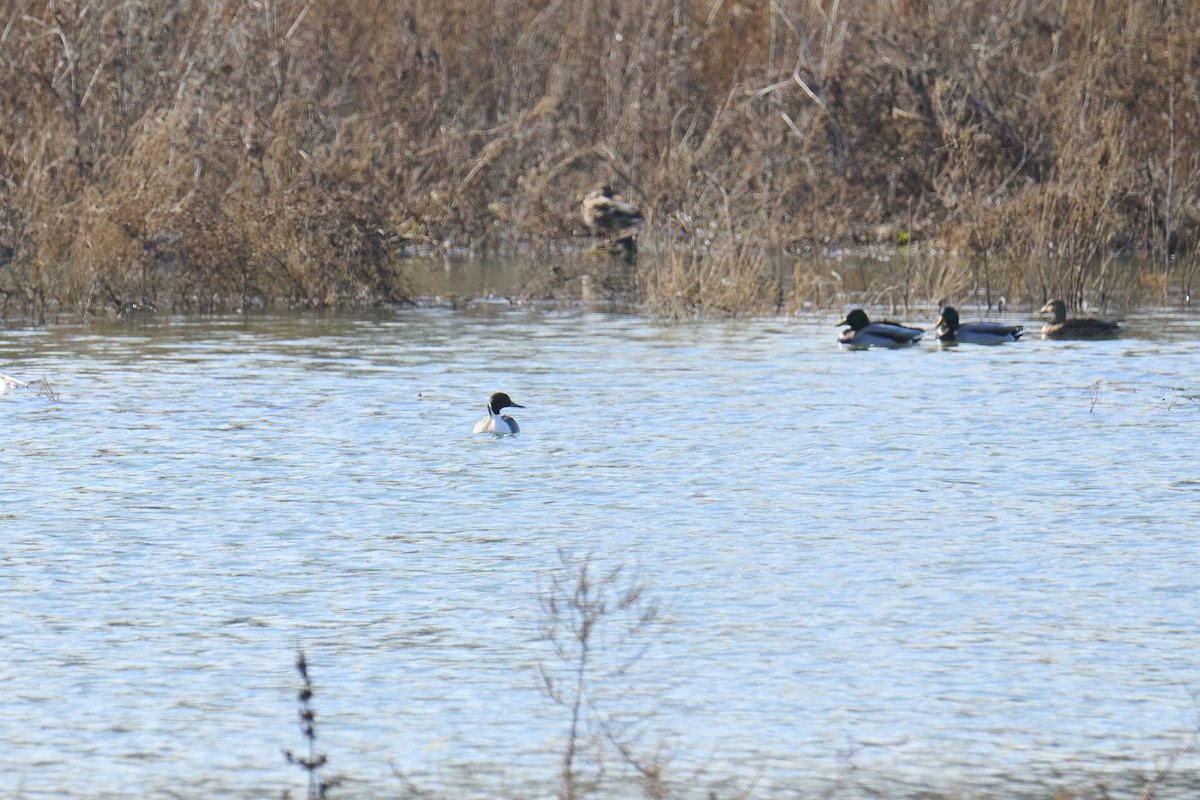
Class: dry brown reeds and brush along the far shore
0,0,1200,319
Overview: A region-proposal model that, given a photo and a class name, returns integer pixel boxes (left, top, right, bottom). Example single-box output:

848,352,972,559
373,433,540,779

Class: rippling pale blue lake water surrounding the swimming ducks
0,305,1200,800
